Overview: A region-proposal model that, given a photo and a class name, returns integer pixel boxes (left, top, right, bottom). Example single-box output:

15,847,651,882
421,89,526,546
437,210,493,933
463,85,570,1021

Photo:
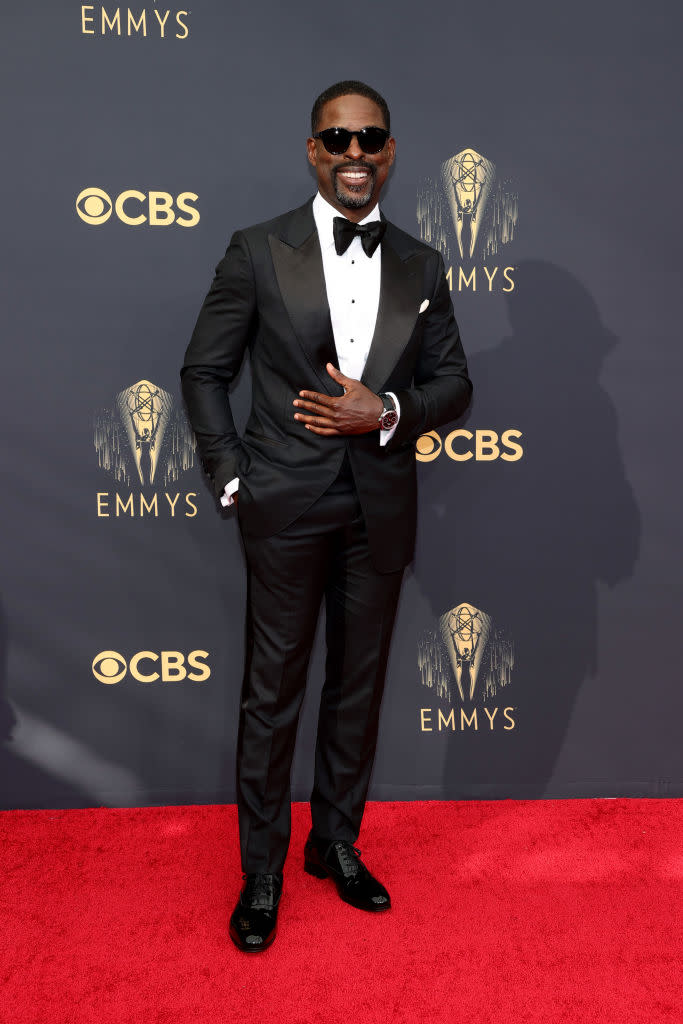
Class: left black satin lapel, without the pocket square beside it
268,228,341,394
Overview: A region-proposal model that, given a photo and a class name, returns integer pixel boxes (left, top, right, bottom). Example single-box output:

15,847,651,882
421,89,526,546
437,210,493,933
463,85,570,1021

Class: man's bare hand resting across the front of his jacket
294,362,384,437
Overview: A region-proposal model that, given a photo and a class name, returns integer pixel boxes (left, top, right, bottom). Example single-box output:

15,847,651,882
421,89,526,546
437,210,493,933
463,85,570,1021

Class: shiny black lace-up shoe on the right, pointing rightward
303,831,391,913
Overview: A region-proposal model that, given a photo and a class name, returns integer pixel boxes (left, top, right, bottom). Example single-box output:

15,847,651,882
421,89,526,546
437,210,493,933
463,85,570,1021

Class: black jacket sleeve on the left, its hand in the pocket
180,231,256,496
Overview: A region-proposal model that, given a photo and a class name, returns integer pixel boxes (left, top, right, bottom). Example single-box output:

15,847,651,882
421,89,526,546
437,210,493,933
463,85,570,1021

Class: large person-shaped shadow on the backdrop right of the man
416,261,640,797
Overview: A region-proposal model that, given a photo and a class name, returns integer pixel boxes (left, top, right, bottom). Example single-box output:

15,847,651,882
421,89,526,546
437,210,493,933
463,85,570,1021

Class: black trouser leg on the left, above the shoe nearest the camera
237,484,357,872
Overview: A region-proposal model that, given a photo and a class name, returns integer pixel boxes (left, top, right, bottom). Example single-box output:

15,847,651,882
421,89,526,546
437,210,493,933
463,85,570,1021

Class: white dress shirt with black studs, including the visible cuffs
220,193,400,505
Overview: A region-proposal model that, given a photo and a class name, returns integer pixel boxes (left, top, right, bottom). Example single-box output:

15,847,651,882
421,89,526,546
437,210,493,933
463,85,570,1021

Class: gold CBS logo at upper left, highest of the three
76,188,200,227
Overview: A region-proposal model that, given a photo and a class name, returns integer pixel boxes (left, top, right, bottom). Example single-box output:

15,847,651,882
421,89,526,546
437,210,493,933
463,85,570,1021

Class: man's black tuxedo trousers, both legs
237,460,402,871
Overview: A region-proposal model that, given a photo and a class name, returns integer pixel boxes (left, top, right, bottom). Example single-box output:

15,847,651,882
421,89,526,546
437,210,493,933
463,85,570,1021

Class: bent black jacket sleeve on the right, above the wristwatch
388,253,472,447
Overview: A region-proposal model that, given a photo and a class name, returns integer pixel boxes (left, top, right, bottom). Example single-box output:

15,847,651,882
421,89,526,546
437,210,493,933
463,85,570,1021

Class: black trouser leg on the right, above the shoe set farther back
311,499,403,843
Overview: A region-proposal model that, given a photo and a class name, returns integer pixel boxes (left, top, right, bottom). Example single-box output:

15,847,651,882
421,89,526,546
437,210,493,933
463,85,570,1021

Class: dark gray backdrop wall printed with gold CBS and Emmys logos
0,0,683,807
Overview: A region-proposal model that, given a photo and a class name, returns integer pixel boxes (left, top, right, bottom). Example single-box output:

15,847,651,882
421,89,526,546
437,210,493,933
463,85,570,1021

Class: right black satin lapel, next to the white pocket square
360,237,422,391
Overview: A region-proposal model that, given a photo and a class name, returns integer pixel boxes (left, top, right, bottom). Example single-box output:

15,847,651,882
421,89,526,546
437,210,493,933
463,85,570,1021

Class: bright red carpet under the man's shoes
0,800,683,1024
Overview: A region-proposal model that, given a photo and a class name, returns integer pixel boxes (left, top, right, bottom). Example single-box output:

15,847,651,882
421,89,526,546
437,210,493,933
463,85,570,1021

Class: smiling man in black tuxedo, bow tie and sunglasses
181,82,471,951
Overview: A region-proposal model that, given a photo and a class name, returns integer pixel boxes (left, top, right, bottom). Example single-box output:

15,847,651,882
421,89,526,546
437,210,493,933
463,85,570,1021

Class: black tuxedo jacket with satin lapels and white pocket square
181,199,472,572
